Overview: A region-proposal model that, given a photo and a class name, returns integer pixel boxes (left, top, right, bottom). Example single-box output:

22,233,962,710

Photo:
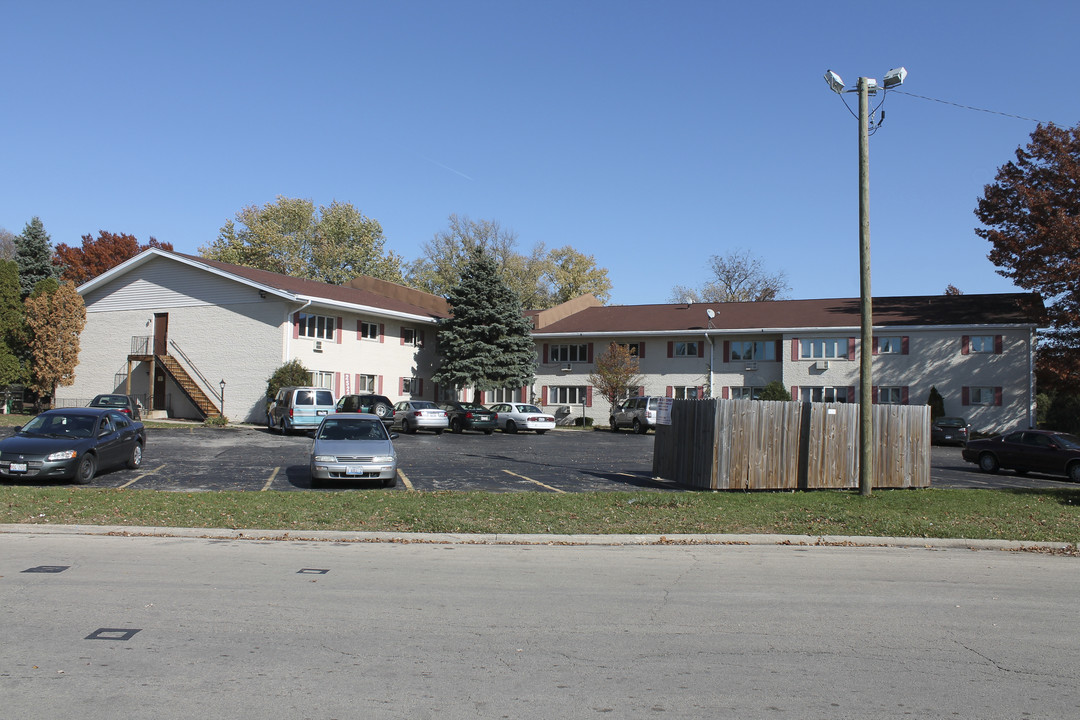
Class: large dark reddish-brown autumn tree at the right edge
975,124,1080,392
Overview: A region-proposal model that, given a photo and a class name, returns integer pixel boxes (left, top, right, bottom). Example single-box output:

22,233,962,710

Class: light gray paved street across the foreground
0,534,1080,720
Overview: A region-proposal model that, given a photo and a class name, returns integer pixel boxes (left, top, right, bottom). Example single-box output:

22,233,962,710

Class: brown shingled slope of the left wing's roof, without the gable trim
173,253,449,320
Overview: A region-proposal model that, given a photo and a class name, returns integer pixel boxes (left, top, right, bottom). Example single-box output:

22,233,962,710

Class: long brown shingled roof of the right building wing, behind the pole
534,293,1044,336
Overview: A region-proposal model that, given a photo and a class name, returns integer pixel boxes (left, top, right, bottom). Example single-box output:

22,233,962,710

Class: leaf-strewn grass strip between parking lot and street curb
0,485,1080,544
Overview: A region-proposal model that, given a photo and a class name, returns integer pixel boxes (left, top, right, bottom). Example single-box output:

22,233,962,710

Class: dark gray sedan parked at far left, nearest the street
0,408,146,484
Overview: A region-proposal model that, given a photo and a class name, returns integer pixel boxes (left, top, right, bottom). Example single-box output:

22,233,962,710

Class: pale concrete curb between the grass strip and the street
0,524,1077,555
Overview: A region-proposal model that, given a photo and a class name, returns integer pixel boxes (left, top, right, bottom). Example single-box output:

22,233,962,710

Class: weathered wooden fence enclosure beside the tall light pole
652,399,930,490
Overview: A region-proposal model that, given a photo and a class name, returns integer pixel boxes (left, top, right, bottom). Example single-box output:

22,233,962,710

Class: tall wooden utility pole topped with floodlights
825,67,907,495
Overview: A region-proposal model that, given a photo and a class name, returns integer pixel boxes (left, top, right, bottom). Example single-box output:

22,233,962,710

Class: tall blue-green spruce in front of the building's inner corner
434,248,537,402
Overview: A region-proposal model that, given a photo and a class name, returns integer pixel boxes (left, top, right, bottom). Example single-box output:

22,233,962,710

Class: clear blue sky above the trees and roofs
0,0,1080,303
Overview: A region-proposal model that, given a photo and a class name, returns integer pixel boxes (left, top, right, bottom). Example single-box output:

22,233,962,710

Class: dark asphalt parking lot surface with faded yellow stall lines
4,424,1075,492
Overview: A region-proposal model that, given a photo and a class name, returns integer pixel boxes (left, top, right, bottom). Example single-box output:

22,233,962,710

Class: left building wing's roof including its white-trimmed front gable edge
79,247,449,320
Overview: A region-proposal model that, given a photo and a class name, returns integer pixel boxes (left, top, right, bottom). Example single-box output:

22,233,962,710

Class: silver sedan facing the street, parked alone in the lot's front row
310,412,397,488
